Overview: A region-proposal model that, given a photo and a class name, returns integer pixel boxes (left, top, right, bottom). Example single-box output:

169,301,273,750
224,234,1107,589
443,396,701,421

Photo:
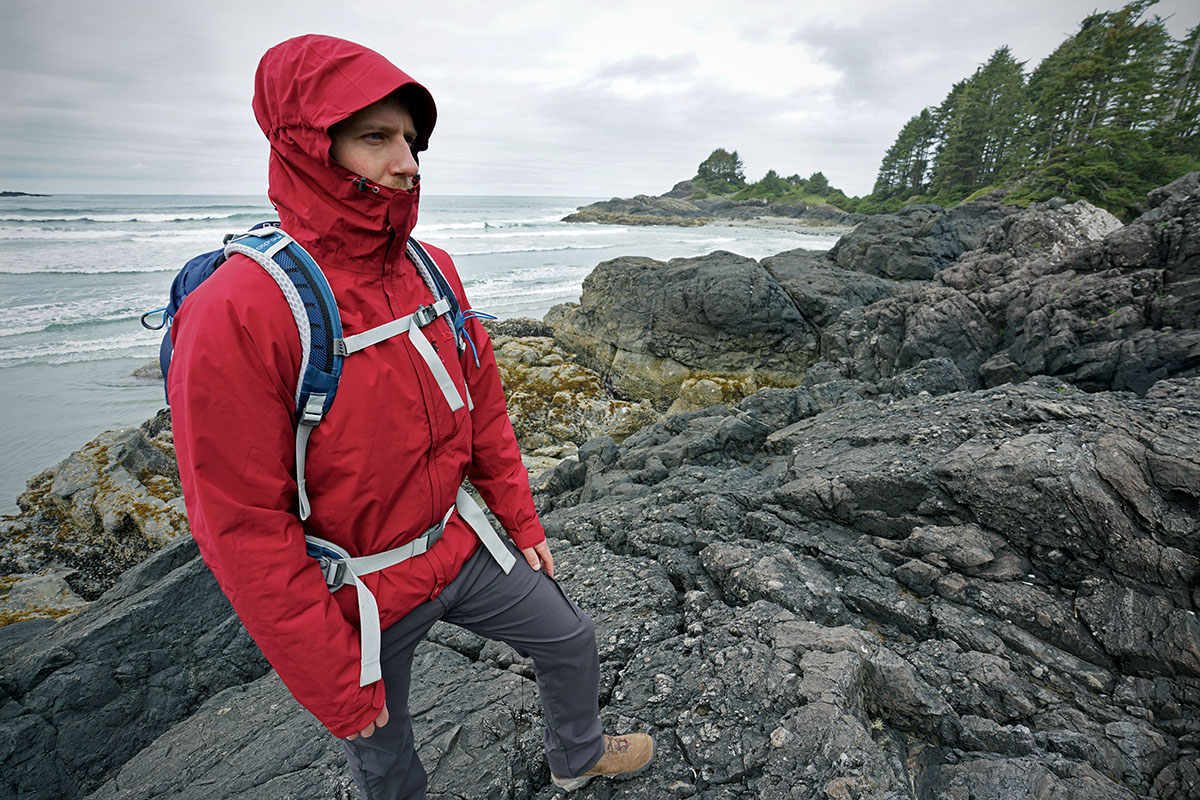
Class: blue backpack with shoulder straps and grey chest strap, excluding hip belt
142,222,496,519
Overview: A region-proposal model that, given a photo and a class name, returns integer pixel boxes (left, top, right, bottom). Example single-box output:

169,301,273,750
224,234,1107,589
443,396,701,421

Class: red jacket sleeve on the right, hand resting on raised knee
427,247,546,548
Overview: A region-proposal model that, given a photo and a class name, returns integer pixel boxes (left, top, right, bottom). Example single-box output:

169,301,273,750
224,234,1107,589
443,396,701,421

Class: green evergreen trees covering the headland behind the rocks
688,0,1200,219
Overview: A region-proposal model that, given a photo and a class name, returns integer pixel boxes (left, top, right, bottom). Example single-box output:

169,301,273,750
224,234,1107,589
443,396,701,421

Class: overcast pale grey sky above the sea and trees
0,0,1200,197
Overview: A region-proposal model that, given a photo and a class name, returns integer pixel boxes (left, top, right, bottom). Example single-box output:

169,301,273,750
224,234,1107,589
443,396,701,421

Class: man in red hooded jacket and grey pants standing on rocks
168,36,653,799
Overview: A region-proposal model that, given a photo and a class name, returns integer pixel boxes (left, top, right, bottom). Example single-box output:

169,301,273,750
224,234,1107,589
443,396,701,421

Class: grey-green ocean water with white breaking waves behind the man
0,194,836,513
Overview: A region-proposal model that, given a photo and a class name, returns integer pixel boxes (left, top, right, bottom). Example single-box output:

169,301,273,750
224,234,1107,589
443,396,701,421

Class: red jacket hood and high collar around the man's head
253,35,437,272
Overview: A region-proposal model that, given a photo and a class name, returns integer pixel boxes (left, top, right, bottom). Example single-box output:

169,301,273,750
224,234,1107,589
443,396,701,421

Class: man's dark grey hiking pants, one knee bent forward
342,539,604,800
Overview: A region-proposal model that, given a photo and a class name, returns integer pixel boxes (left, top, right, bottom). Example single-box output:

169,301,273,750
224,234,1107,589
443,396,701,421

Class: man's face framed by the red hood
329,97,418,190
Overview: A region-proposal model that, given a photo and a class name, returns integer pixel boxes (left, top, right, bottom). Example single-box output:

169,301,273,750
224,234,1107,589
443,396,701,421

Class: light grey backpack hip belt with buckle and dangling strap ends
305,487,516,686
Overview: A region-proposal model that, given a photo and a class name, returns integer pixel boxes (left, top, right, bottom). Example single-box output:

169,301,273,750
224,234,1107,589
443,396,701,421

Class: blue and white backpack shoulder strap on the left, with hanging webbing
224,228,342,519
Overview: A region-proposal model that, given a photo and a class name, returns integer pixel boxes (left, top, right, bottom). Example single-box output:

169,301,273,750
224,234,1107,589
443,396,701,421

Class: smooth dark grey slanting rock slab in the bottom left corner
0,537,268,798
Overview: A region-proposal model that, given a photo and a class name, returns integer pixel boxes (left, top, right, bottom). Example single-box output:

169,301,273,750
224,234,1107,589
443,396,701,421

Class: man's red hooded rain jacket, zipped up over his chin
168,36,545,736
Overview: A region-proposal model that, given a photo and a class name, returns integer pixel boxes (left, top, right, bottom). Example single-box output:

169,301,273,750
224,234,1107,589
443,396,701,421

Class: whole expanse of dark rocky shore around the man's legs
0,174,1200,800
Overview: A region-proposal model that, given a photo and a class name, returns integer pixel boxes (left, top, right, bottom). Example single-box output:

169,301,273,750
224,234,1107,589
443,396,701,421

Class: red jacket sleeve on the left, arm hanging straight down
168,262,384,736
